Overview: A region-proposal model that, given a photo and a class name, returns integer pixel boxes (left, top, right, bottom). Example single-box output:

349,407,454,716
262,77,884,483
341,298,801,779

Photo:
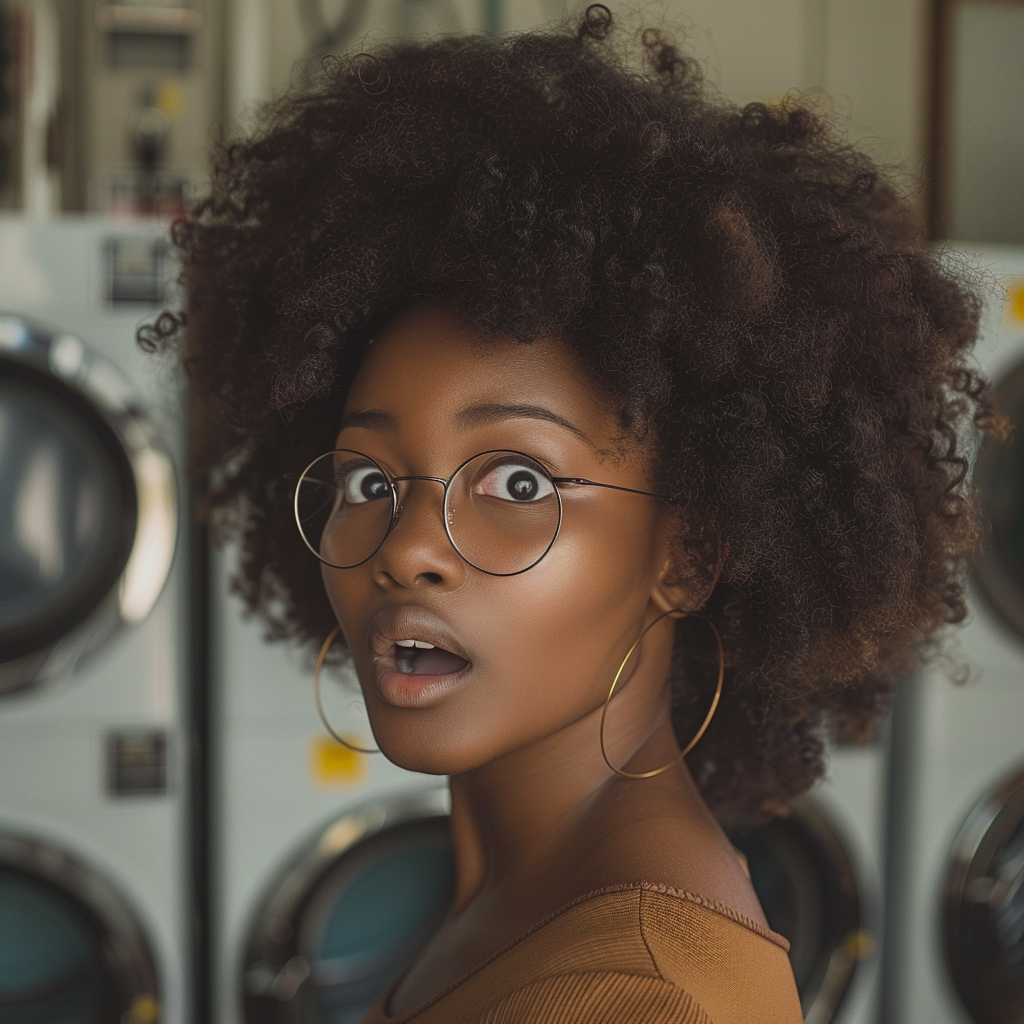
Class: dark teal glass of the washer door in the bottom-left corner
0,870,116,1024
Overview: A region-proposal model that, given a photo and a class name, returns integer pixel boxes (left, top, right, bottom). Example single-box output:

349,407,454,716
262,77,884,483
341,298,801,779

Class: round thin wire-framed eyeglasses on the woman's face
295,449,668,575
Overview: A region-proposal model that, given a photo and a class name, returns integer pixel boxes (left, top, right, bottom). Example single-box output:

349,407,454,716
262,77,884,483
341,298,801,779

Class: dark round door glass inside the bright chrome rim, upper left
0,359,137,662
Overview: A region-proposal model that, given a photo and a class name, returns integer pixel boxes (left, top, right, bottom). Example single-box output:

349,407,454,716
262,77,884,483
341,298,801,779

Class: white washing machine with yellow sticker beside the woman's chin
209,549,455,1024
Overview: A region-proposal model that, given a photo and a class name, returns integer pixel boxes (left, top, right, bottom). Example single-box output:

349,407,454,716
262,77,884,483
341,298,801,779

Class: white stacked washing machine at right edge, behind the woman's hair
884,244,1024,1024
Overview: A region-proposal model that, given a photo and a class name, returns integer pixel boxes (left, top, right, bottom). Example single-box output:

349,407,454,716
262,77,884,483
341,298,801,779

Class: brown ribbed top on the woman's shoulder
364,882,803,1024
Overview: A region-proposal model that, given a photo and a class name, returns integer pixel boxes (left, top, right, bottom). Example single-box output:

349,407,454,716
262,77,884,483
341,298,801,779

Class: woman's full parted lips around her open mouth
369,605,473,708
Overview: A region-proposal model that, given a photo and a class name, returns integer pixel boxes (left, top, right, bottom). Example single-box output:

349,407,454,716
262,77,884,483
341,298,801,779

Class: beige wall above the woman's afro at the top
227,0,928,197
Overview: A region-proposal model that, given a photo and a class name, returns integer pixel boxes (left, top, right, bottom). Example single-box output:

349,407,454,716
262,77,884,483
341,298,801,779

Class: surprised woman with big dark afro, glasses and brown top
147,6,1000,1024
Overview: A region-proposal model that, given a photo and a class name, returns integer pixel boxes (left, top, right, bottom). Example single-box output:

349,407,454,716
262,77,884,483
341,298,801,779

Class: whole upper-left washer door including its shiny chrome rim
0,312,177,696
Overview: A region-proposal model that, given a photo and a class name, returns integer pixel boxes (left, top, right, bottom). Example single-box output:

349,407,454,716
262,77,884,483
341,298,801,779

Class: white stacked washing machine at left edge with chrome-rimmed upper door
0,218,190,1024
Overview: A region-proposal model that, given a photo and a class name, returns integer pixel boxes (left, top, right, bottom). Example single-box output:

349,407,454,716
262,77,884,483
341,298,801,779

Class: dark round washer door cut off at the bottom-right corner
943,770,1024,1024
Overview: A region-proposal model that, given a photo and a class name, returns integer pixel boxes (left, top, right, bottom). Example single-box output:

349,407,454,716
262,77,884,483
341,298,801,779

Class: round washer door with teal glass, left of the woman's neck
244,816,455,1024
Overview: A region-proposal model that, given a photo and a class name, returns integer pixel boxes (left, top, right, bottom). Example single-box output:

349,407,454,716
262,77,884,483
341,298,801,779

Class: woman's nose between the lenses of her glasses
374,477,467,590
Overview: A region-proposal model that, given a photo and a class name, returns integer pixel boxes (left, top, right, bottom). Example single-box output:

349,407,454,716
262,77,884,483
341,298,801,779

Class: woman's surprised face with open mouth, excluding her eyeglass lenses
324,304,669,774
